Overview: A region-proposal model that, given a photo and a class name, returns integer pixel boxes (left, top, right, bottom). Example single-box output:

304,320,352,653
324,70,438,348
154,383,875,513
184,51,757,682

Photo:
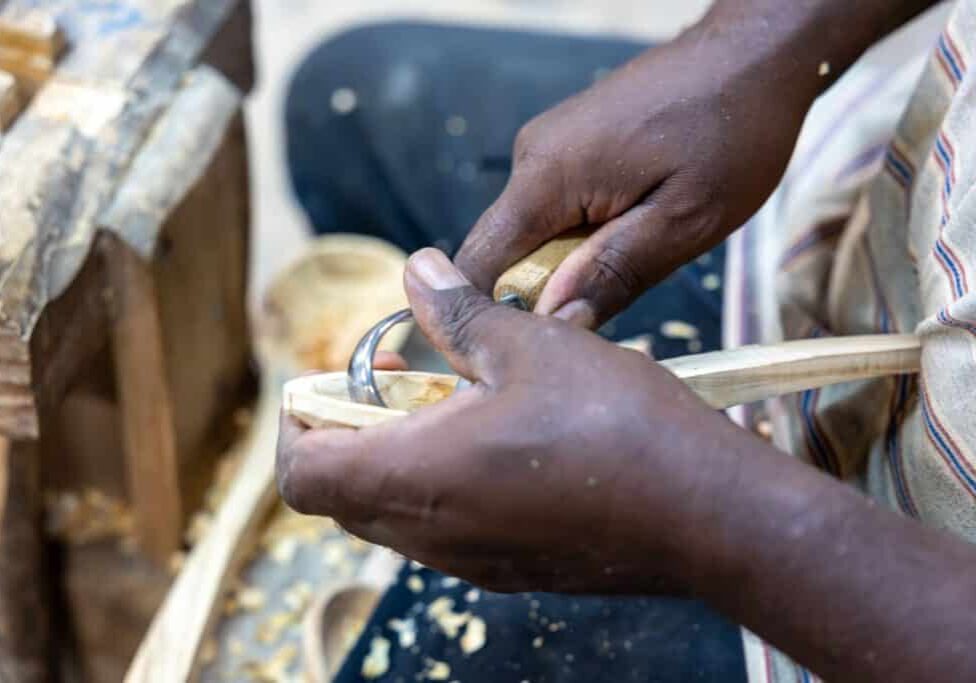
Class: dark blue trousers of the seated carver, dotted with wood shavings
286,24,745,683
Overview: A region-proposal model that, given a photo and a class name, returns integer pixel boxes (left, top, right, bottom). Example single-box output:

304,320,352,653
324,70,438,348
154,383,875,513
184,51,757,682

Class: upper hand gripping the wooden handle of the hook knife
455,16,822,327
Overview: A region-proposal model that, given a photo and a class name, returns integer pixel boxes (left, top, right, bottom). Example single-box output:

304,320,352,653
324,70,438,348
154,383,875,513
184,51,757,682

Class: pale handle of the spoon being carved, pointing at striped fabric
661,334,921,408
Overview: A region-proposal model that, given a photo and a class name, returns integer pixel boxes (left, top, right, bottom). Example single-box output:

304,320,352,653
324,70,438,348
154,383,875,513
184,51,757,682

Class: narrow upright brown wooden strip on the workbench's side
108,243,183,566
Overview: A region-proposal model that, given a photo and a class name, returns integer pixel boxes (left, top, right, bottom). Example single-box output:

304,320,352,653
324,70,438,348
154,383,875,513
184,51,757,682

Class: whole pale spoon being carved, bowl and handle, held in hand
284,335,921,428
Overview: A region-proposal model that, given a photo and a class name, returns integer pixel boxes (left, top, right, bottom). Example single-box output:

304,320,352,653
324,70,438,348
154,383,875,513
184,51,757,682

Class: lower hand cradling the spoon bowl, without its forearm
278,250,752,592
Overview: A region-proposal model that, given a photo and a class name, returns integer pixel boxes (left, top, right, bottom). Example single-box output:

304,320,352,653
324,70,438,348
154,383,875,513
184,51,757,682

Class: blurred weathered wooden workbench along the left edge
0,0,252,681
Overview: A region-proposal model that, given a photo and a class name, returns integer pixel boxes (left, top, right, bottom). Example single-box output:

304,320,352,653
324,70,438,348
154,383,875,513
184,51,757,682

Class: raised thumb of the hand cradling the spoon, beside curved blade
404,248,528,384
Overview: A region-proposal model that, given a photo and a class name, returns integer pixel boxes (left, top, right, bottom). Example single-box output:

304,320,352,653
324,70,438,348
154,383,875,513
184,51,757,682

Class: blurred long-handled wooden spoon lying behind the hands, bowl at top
125,235,406,683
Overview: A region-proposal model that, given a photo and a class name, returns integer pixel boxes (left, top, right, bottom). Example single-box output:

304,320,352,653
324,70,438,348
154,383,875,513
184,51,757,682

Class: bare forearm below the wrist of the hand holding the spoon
694,424,976,681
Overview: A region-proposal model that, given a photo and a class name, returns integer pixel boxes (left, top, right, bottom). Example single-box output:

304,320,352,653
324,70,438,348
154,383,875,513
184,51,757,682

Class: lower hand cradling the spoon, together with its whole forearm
278,250,976,681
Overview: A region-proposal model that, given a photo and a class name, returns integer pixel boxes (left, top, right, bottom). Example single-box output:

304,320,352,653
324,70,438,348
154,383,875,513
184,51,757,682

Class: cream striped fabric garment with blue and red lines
724,0,976,683
